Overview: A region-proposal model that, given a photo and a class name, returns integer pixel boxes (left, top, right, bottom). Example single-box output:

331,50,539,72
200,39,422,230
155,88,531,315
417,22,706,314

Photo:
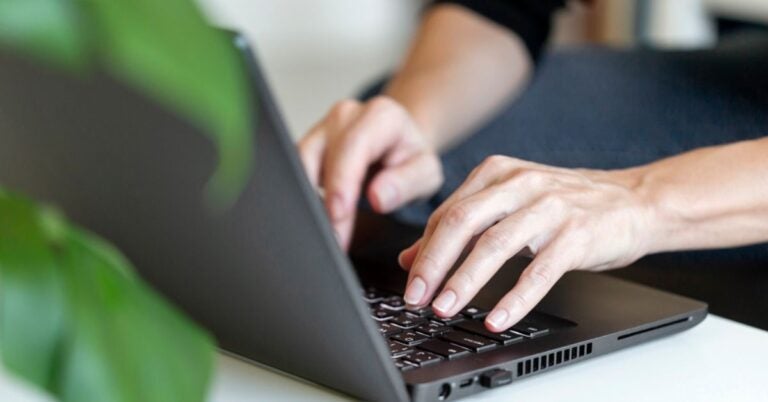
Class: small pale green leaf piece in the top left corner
0,0,86,70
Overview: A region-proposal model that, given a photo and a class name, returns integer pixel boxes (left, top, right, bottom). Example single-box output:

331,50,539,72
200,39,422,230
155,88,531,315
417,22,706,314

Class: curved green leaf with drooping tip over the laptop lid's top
83,0,253,206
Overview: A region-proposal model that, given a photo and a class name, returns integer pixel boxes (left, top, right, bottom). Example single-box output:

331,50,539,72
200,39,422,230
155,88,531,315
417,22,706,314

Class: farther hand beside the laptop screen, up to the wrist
299,96,443,250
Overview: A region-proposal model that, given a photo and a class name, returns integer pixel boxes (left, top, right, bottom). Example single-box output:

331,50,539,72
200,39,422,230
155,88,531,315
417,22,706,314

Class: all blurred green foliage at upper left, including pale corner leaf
0,0,253,207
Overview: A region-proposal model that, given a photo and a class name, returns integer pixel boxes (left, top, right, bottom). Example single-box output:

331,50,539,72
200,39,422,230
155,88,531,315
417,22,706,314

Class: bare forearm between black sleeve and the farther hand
385,5,532,150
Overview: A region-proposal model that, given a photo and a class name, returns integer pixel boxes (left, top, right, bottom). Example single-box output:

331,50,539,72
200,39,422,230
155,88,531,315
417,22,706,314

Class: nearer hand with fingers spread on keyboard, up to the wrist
400,156,652,332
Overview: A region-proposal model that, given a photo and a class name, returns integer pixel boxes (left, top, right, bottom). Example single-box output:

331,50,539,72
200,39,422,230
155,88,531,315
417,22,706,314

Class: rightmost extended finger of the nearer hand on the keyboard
485,232,578,332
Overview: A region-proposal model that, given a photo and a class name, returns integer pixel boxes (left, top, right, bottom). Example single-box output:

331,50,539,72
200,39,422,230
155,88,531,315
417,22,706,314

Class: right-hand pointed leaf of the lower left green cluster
56,231,213,402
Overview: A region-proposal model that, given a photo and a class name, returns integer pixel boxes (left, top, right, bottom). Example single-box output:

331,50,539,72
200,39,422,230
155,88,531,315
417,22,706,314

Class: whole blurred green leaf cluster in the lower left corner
0,191,214,402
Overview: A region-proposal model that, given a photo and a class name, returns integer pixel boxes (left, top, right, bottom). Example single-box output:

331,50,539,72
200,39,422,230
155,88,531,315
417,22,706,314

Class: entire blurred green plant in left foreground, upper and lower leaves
0,0,253,402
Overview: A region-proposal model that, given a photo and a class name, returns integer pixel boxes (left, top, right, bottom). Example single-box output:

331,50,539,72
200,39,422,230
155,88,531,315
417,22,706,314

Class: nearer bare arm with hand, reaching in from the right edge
400,138,768,331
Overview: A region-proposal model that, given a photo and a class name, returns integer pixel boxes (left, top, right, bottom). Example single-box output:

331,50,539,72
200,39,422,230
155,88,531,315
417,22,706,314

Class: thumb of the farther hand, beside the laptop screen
368,152,443,214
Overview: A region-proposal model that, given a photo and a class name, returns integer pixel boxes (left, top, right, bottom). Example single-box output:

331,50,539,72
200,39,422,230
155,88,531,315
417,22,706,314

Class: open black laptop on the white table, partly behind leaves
0,38,707,401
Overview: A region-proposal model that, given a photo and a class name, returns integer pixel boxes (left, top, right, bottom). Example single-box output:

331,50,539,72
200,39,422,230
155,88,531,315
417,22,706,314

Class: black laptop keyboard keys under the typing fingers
363,288,558,371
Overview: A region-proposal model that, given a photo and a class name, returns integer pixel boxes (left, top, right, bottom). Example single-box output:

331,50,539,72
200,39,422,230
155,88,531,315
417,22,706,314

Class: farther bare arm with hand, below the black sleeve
299,5,532,247
